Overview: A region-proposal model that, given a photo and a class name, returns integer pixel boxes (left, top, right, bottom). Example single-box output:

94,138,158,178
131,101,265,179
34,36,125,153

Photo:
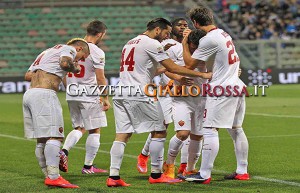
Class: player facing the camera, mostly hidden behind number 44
137,18,190,174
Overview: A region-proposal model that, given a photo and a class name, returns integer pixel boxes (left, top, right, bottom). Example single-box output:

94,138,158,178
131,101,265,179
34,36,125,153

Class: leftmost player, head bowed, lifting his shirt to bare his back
23,38,90,188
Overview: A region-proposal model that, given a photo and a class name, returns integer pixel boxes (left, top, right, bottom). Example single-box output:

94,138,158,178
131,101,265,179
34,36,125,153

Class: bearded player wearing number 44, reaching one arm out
106,18,211,187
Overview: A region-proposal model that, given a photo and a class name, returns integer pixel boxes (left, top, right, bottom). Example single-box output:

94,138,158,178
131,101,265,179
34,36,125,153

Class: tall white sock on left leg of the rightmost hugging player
200,128,219,179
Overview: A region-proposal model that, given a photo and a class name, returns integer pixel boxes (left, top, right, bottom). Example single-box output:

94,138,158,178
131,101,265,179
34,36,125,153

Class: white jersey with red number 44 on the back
115,34,169,100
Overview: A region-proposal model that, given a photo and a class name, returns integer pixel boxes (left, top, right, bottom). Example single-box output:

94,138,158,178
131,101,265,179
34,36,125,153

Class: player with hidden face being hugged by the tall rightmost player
163,30,207,178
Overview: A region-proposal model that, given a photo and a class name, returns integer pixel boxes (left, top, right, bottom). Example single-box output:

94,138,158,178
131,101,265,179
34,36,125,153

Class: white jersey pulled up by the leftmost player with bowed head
29,44,77,79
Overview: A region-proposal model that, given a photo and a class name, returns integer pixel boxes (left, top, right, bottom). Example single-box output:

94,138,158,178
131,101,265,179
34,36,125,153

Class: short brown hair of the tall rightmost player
188,5,214,26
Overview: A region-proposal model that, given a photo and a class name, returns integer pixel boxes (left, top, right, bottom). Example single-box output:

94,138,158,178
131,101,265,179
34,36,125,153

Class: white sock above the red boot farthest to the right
227,128,249,174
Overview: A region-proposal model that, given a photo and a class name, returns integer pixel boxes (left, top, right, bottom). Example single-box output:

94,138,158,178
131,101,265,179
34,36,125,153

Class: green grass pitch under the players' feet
0,85,300,193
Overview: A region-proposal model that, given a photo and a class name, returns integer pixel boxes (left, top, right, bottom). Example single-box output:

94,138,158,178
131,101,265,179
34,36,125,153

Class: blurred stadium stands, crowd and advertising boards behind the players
0,0,300,93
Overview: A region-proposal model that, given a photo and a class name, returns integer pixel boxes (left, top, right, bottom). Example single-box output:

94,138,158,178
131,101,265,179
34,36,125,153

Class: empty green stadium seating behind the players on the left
0,6,167,76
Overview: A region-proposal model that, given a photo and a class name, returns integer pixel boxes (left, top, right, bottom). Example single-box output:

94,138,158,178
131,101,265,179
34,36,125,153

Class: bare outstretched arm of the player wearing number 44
160,59,212,79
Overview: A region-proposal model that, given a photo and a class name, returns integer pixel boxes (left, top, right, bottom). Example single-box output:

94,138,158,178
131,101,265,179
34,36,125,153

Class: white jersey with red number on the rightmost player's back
192,28,245,88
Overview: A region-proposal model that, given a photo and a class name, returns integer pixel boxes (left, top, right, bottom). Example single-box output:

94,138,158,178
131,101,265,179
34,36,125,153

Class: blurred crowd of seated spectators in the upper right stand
217,0,300,40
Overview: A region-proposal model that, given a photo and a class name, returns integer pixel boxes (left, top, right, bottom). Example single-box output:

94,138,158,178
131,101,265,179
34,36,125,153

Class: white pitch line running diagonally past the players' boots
0,134,300,187
